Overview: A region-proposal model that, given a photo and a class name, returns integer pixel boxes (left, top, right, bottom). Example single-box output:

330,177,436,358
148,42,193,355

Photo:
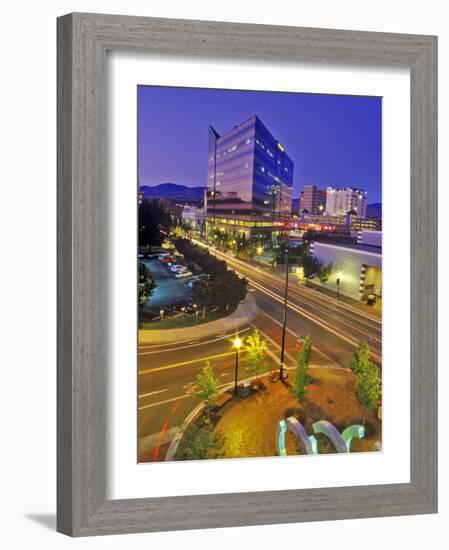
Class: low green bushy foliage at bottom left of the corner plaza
175,424,225,460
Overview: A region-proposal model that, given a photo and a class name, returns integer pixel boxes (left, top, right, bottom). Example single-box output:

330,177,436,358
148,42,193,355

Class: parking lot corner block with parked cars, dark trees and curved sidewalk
139,238,255,343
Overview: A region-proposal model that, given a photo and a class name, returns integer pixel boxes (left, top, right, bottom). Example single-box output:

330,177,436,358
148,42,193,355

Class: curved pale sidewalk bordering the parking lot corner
139,292,257,345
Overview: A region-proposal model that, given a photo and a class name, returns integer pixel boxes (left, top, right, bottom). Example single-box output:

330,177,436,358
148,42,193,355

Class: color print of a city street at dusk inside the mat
137,85,382,463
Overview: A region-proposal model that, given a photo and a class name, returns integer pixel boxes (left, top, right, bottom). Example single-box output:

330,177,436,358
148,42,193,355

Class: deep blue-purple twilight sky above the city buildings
137,86,382,203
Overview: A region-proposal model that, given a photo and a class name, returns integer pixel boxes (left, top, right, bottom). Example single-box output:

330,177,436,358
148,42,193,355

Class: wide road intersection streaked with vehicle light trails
138,243,382,461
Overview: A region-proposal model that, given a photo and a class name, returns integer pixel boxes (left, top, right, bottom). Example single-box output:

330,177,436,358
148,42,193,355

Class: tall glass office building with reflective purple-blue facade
207,116,293,220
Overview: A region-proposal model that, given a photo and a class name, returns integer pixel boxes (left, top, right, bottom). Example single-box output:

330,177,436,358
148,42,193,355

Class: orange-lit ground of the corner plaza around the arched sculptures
215,367,382,458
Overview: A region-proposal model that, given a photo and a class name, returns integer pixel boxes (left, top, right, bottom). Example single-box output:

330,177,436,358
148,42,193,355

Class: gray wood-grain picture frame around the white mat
57,13,437,536
